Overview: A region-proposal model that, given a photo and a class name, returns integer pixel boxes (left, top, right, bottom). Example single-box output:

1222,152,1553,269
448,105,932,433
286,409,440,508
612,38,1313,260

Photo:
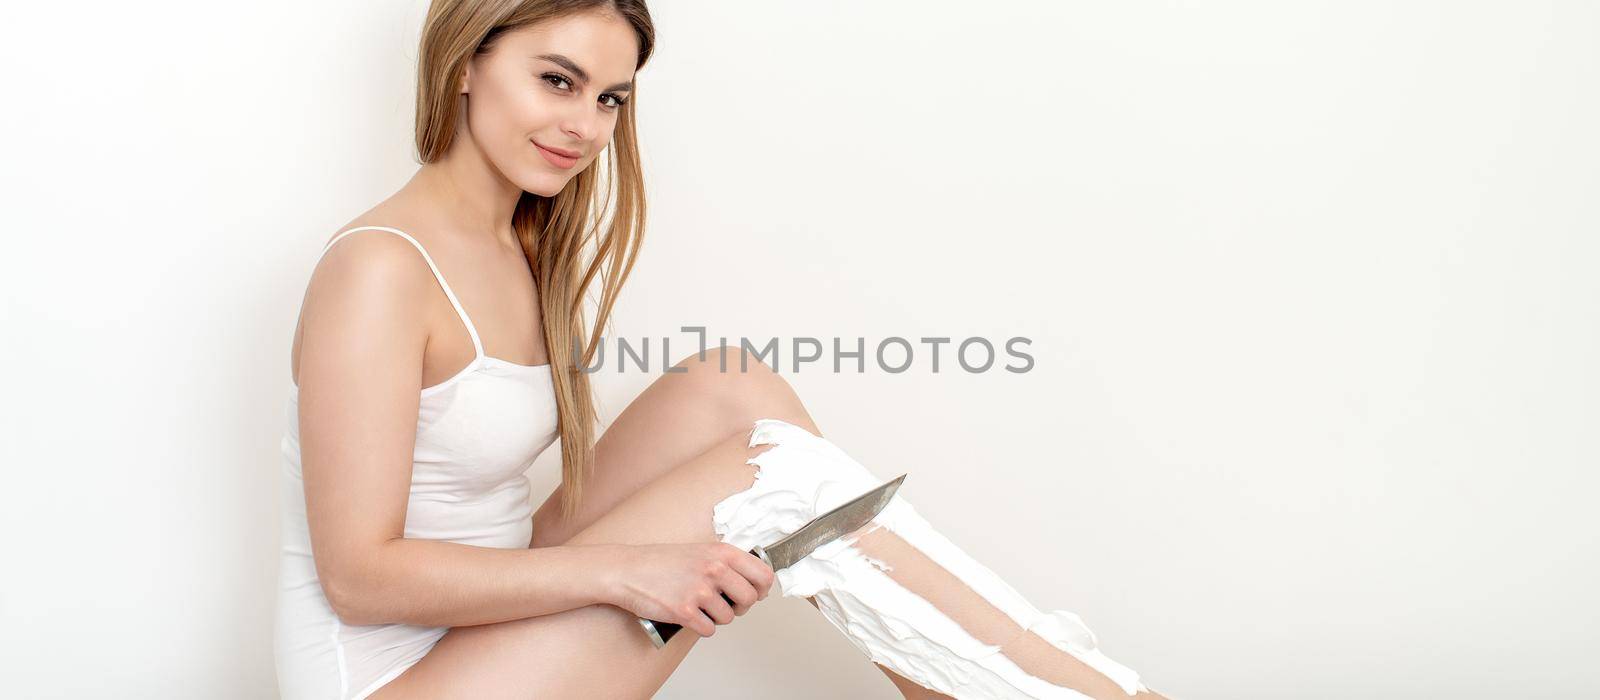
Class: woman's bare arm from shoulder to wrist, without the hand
299,233,624,626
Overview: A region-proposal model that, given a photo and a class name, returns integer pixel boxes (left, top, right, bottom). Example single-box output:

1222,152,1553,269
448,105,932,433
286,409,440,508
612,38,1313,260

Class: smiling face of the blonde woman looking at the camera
461,13,638,197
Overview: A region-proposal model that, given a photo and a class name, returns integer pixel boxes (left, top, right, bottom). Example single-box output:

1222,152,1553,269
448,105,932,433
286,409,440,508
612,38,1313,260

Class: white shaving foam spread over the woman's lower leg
712,419,1146,698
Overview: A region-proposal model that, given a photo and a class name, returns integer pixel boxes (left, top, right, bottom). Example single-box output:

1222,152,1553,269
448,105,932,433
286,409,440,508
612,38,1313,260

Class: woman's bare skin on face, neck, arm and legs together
291,6,1171,698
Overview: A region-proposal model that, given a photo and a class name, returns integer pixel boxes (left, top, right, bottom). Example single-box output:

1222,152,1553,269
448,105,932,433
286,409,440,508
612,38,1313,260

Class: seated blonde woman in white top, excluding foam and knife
277,0,1157,698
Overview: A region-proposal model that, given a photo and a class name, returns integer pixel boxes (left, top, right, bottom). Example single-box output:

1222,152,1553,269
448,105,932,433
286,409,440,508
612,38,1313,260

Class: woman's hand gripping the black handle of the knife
606,542,776,636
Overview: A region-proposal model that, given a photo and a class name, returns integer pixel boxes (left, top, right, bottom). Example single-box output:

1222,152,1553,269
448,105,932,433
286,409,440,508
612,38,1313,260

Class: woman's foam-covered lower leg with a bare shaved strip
714,420,1160,698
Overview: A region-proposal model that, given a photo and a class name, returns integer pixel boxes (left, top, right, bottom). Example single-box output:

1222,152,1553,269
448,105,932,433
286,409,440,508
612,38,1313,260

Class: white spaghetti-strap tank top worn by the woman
274,225,557,698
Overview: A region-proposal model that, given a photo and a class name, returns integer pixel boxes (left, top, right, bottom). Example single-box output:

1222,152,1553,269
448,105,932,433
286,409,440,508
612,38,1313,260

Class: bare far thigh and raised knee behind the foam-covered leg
533,347,821,547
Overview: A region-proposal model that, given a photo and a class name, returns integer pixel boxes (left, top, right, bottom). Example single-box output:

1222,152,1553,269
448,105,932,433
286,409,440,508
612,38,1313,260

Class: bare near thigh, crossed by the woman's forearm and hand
364,430,787,700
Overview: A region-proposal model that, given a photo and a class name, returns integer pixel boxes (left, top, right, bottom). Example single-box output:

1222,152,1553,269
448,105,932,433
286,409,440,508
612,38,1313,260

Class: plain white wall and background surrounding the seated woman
0,0,1600,698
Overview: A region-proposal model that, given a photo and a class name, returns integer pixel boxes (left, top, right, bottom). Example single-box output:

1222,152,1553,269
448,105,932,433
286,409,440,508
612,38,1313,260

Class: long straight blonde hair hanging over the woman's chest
416,0,656,518
